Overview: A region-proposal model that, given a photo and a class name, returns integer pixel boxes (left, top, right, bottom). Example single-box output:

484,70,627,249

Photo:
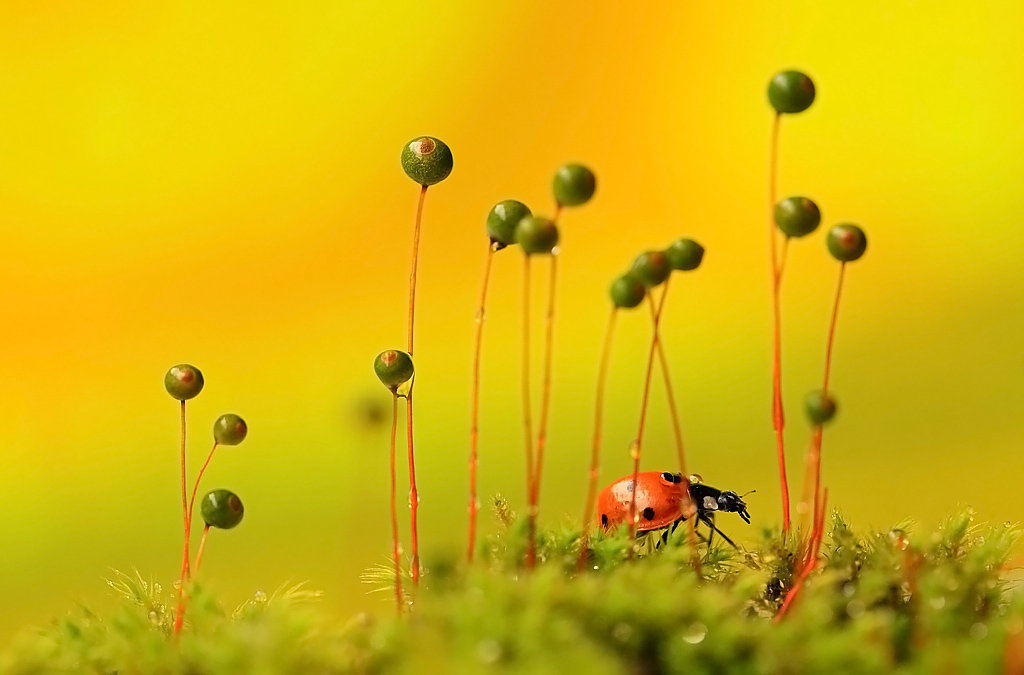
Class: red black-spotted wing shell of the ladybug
597,471,684,532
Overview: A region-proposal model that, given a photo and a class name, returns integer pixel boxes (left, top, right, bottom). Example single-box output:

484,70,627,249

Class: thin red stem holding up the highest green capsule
768,114,790,535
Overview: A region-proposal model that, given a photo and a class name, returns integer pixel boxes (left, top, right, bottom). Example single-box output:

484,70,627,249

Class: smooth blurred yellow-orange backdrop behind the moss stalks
0,0,1024,641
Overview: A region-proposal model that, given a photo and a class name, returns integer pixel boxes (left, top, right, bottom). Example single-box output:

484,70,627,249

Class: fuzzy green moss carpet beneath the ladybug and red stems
0,504,1024,675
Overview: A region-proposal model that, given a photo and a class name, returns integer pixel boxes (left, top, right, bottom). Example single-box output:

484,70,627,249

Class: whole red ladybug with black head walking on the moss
597,471,751,547
